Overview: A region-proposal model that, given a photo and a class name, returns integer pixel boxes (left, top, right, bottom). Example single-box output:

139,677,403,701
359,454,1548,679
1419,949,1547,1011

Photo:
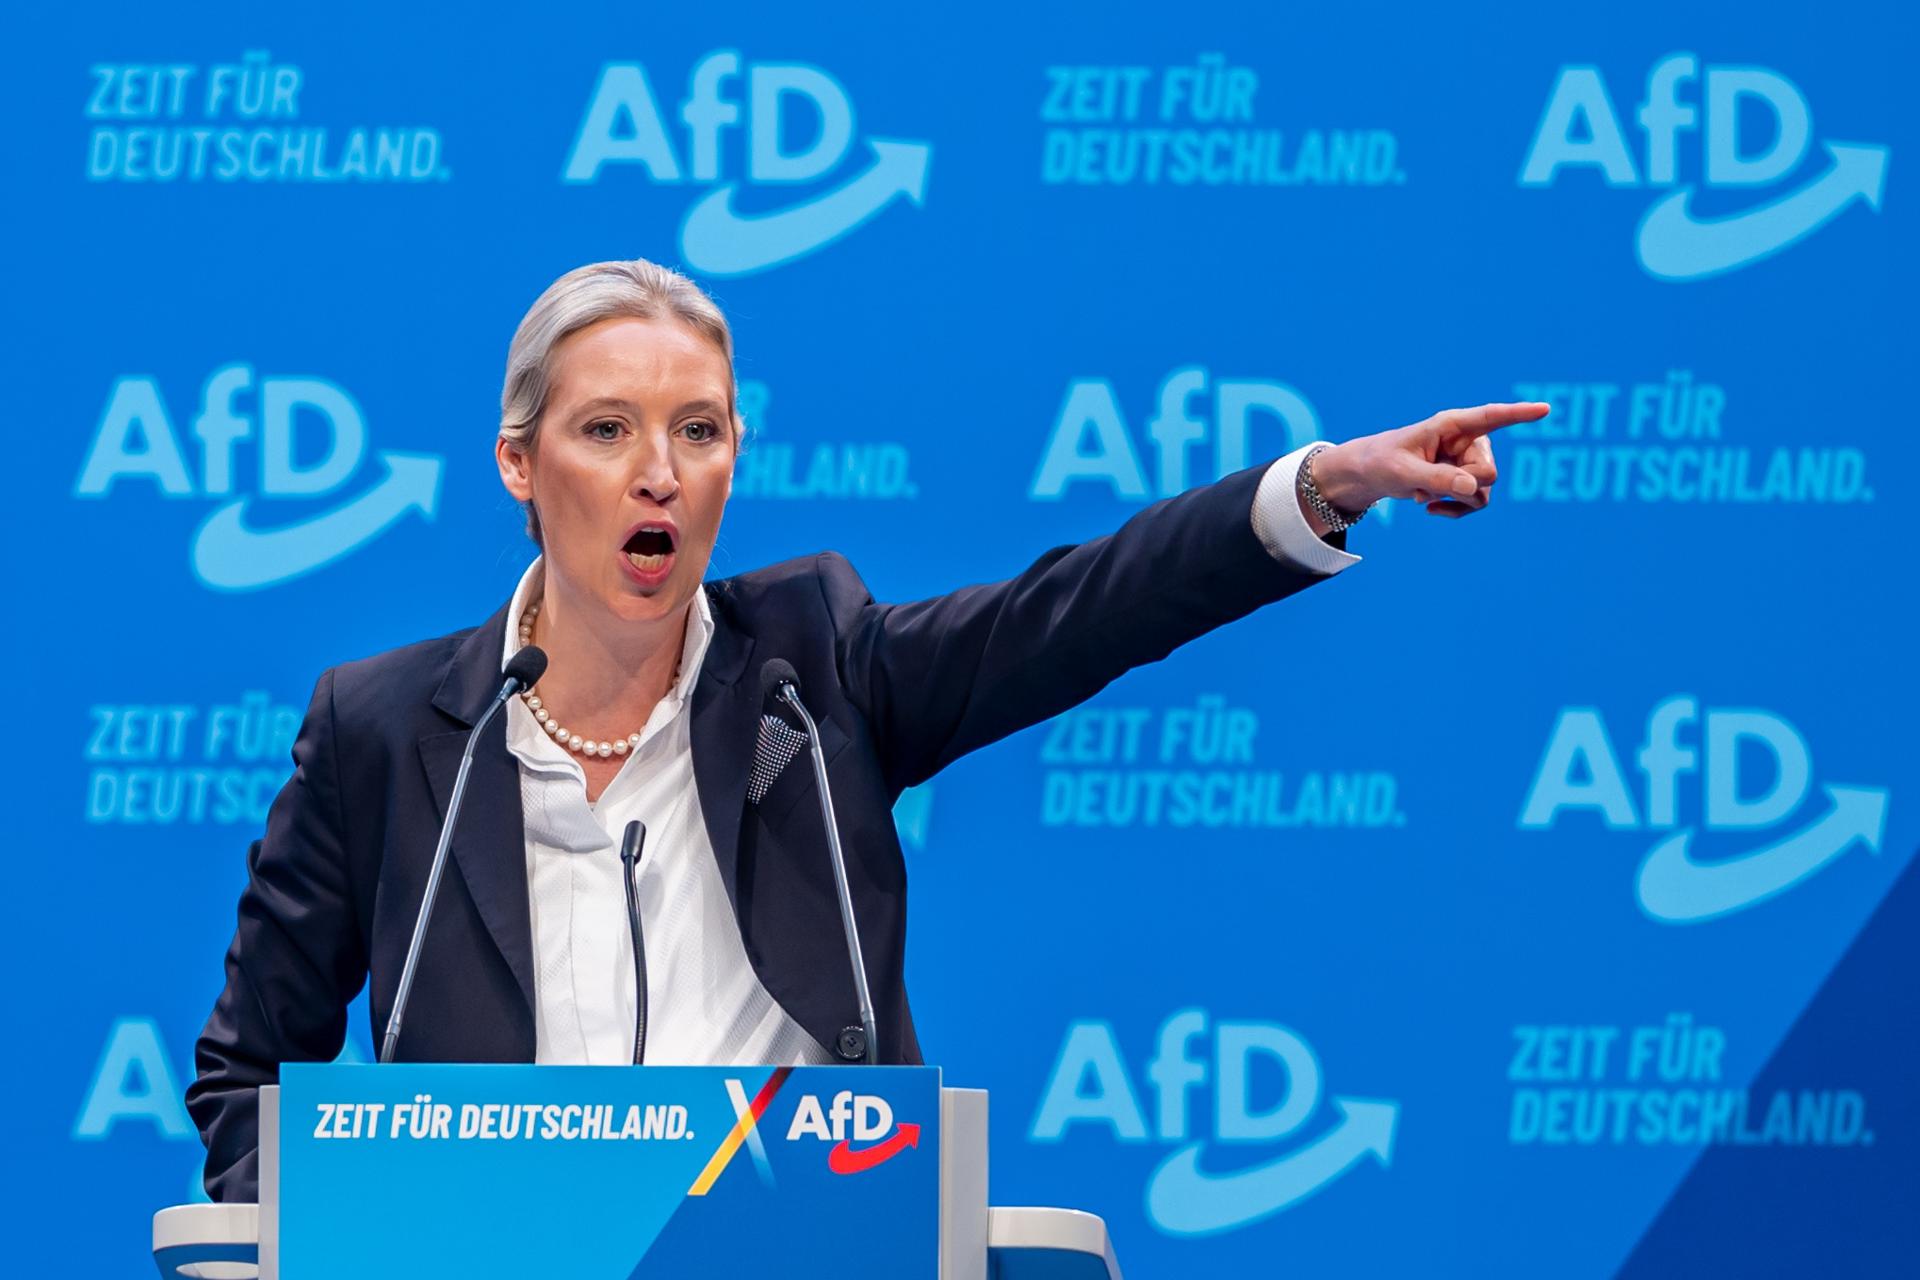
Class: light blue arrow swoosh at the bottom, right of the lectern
1146,1098,1400,1236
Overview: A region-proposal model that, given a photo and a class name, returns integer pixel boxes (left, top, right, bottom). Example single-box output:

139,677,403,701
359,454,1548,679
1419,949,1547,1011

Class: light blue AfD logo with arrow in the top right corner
1521,54,1889,280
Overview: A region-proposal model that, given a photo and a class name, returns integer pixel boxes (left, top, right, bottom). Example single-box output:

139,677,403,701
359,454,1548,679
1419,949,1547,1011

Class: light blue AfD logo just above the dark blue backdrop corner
1519,695,1887,925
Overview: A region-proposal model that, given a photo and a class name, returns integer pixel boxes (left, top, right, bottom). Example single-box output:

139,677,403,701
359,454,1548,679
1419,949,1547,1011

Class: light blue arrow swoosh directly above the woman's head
680,138,933,276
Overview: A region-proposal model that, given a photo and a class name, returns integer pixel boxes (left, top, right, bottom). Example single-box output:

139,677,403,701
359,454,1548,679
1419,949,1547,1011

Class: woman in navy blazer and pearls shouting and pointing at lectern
186,261,1548,1199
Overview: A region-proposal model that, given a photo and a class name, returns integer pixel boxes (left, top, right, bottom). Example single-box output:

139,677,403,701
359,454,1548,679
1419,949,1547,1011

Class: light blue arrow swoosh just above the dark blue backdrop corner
1640,787,1887,925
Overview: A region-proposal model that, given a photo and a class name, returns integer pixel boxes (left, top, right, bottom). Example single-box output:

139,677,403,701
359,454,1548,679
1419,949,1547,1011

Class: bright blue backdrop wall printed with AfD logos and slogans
11,0,1920,1276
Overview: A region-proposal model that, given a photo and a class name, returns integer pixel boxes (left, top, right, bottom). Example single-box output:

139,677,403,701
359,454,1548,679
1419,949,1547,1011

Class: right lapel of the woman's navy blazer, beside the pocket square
691,587,760,919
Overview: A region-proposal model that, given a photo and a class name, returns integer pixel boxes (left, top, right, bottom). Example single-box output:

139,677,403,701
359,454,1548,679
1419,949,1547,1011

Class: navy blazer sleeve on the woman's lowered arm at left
186,672,367,1201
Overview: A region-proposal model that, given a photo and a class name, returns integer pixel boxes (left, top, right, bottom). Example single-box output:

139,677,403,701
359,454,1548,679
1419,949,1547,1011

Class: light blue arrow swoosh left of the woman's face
194,451,440,591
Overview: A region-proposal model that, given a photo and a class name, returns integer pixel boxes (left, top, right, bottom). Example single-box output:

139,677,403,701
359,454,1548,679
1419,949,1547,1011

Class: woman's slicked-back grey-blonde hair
499,257,745,543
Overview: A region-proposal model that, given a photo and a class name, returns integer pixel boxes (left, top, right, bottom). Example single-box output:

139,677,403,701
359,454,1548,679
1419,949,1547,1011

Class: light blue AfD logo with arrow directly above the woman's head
561,50,933,276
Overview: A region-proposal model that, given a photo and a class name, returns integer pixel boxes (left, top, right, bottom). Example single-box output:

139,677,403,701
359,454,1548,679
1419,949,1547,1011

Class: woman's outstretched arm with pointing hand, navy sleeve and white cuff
822,405,1546,789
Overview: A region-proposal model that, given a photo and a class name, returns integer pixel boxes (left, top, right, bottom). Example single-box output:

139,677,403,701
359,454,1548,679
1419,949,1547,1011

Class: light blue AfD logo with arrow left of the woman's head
73,365,442,591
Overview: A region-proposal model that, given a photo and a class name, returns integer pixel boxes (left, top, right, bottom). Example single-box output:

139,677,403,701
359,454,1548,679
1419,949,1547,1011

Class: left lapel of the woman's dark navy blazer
420,608,534,1009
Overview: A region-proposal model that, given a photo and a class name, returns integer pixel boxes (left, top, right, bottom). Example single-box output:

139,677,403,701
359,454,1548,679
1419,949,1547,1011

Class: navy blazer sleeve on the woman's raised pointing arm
820,466,1325,789
